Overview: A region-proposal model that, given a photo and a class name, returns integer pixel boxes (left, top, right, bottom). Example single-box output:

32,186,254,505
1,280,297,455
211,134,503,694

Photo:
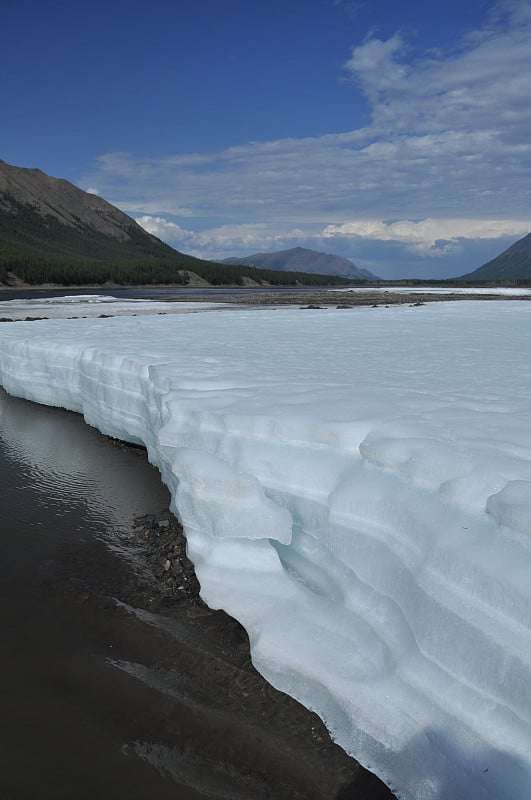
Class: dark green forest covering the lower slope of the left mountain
0,198,358,286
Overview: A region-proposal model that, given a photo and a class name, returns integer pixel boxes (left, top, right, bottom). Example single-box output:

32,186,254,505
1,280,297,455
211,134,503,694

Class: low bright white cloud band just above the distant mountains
137,216,531,278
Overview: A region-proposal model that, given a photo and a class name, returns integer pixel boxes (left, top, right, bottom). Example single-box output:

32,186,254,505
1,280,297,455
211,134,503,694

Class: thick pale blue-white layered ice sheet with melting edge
0,301,531,800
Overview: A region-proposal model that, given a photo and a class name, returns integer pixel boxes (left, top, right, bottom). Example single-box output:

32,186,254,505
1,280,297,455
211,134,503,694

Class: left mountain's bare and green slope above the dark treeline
0,161,177,261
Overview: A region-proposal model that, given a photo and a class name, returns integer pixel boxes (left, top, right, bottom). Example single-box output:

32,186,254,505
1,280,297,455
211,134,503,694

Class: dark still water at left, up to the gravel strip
0,391,189,800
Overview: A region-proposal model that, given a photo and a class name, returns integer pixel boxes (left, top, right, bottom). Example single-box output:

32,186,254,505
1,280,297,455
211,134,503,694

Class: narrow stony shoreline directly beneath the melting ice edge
124,506,400,800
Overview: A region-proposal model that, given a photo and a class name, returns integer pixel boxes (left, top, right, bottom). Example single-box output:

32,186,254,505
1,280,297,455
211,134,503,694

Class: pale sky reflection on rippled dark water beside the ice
0,389,169,530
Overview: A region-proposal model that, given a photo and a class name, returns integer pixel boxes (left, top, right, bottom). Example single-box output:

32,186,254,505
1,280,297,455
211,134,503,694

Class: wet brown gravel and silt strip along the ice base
123,512,400,800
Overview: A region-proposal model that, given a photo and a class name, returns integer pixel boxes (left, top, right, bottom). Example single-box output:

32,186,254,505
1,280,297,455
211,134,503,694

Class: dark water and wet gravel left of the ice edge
0,393,392,800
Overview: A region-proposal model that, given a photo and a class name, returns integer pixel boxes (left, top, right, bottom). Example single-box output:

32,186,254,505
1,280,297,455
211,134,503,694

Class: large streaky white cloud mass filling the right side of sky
80,0,531,276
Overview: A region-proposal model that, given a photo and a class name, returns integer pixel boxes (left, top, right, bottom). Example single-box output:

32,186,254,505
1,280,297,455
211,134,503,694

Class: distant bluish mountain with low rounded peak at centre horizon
221,247,378,281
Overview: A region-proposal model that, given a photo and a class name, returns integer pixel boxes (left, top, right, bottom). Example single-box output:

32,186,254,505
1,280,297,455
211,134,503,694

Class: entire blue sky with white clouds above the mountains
0,0,531,277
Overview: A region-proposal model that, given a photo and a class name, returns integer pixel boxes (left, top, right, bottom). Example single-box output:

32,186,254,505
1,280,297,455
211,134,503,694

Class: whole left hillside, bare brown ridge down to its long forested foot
0,160,356,286
